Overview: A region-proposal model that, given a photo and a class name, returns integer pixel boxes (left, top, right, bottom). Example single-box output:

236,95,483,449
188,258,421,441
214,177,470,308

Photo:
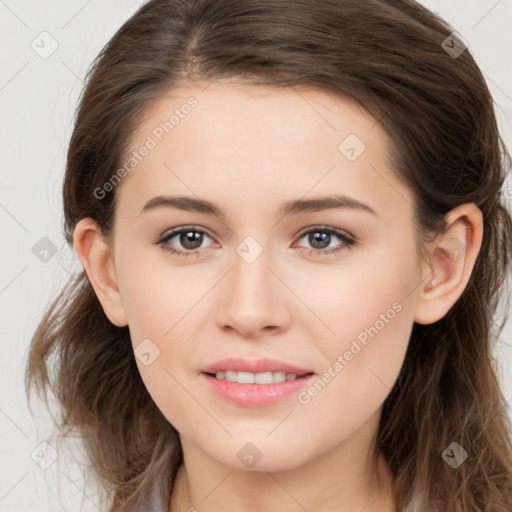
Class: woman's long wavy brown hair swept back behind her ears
26,0,512,512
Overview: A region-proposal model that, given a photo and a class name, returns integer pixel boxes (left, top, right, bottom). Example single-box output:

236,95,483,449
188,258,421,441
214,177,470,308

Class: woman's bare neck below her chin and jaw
170,412,397,512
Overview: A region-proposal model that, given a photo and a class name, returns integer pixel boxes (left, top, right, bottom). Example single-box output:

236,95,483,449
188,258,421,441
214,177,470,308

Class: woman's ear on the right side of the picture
414,203,483,325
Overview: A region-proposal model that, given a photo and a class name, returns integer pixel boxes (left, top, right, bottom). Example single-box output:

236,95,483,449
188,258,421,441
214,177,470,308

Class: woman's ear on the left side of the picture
73,218,128,327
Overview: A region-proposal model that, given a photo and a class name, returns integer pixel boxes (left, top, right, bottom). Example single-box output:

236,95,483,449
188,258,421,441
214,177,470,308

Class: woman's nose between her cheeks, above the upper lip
217,241,293,338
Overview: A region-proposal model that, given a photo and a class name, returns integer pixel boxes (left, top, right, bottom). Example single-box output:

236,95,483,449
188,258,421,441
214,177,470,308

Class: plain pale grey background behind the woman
0,0,512,512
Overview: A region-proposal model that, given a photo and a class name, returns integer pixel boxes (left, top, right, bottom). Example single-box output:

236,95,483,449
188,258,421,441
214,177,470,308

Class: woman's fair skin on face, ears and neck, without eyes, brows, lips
74,81,483,512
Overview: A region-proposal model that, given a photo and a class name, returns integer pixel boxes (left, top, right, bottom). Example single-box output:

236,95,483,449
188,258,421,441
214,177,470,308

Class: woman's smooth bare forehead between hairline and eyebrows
114,81,412,222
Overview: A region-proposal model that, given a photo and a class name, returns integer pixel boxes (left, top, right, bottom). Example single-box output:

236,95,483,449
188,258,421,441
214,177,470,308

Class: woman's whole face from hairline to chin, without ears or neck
105,82,421,470
